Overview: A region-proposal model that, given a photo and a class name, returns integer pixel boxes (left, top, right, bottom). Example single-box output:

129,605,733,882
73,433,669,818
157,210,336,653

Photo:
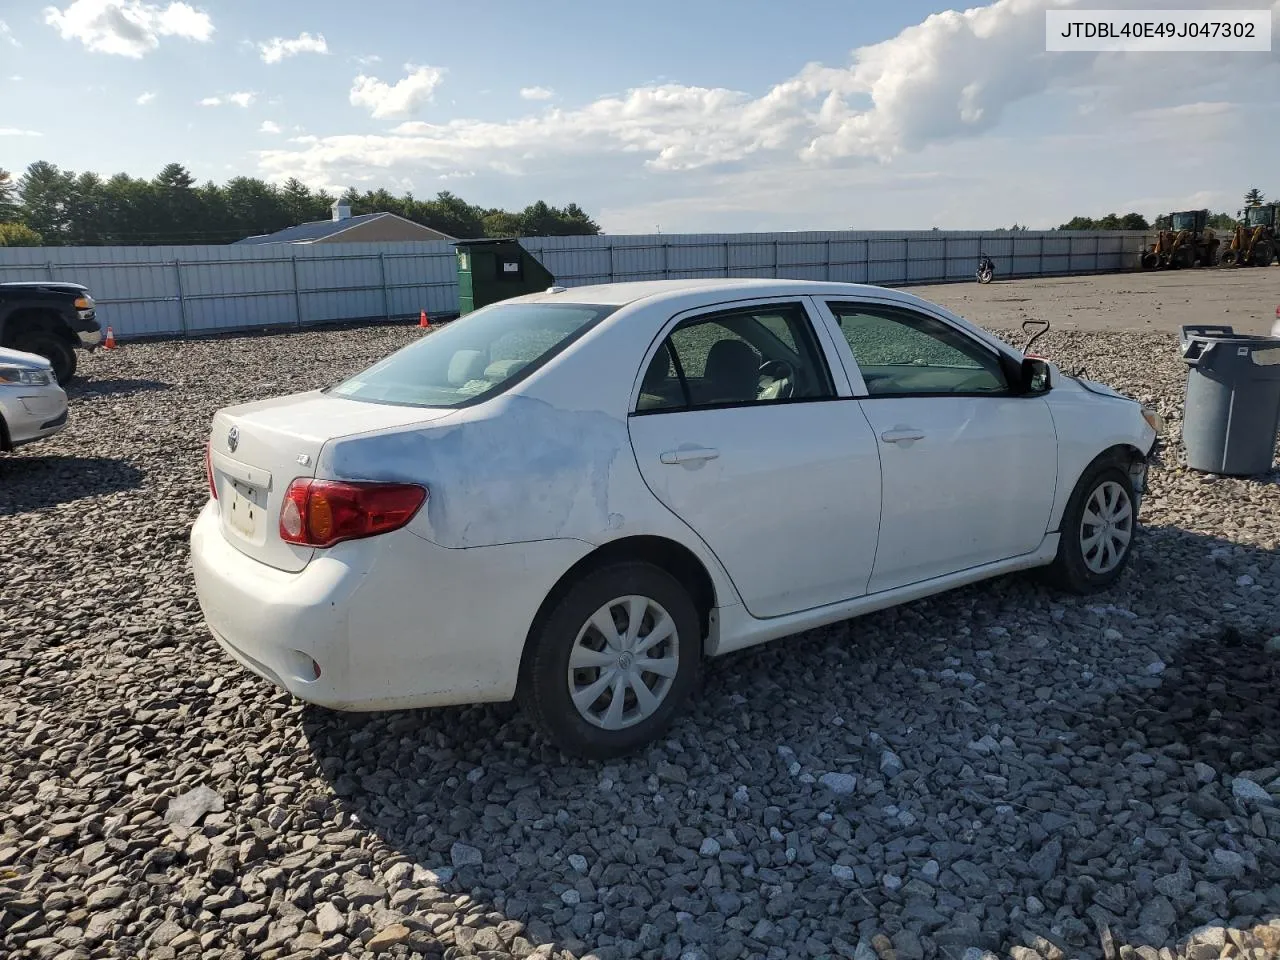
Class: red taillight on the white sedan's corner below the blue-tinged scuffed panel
280,476,428,547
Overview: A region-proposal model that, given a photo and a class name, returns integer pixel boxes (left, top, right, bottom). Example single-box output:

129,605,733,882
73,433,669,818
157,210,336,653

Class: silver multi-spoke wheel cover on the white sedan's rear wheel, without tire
568,595,680,730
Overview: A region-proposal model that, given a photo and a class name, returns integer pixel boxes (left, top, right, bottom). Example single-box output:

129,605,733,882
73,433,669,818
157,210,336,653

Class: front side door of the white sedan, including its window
824,298,1057,593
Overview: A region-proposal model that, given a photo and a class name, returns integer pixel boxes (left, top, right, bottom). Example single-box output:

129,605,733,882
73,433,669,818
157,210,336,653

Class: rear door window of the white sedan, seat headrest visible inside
636,303,835,413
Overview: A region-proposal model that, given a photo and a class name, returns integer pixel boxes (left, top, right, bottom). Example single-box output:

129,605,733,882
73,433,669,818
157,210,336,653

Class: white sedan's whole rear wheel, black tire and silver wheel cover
520,562,703,760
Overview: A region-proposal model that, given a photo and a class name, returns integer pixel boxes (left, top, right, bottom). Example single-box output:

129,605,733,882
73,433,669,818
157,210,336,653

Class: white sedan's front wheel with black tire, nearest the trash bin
1043,461,1138,595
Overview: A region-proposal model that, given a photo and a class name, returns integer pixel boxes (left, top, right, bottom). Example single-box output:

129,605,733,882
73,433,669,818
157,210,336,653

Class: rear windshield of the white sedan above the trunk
330,303,617,407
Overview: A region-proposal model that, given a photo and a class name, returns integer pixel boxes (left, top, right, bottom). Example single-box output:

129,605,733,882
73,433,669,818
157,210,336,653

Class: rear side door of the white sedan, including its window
628,297,881,617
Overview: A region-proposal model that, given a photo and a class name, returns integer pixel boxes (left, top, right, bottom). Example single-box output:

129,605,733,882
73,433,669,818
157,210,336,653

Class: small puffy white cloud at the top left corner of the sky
45,0,214,59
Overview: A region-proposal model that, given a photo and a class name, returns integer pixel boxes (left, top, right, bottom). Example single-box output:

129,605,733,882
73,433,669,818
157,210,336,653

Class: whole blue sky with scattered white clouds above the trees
0,0,1280,233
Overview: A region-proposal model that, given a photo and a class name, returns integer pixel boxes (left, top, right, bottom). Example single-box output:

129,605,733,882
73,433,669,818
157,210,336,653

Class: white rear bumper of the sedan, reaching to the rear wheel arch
191,500,590,710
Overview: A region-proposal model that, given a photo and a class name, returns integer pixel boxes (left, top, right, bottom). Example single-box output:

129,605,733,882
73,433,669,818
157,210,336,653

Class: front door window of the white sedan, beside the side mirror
828,303,1009,397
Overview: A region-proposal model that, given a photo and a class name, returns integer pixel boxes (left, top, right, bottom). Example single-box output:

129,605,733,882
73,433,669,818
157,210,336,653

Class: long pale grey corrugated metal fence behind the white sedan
0,230,1149,338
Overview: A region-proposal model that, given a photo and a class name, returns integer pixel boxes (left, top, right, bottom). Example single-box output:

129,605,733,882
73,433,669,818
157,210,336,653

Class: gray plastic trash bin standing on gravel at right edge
1181,325,1280,476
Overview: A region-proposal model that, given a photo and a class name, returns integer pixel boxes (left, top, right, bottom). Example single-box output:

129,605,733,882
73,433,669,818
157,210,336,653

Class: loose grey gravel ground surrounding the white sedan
0,317,1280,960
